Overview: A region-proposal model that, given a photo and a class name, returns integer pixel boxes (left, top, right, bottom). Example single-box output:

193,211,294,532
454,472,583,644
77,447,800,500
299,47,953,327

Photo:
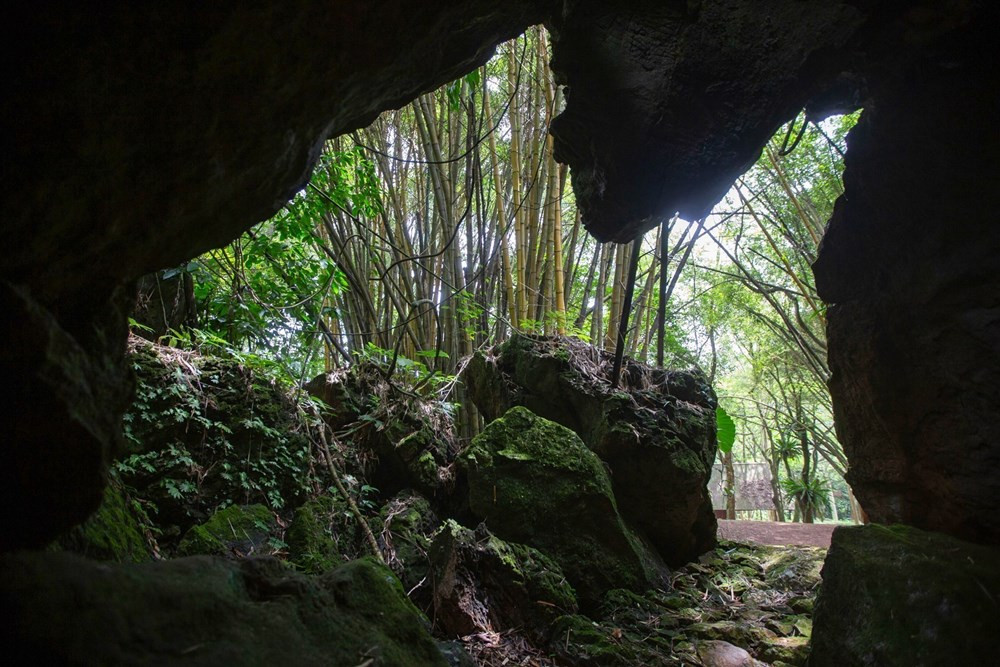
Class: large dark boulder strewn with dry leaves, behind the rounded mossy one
465,335,717,566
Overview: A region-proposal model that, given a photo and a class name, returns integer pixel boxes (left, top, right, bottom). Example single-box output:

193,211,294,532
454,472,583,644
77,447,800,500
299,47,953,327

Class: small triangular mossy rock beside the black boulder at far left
55,479,152,563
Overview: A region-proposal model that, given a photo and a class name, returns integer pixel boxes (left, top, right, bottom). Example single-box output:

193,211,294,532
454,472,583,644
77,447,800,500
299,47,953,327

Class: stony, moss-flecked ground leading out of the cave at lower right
462,542,826,667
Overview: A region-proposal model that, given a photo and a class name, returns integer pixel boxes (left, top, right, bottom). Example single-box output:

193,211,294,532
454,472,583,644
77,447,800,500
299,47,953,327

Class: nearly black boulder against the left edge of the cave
0,280,132,551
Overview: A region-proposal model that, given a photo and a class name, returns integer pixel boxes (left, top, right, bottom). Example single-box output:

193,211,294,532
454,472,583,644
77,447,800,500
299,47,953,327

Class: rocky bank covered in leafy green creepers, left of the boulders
114,340,319,525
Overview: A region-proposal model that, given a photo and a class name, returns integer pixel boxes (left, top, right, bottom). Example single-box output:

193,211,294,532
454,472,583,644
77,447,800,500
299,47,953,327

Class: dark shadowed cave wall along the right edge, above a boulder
814,20,1000,544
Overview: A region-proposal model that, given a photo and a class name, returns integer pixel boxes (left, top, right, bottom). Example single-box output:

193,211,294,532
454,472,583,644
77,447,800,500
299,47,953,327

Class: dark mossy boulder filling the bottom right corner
809,524,1000,667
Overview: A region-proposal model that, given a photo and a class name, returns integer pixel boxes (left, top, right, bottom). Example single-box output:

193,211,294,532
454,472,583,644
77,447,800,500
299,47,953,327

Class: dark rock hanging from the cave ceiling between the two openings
552,0,869,242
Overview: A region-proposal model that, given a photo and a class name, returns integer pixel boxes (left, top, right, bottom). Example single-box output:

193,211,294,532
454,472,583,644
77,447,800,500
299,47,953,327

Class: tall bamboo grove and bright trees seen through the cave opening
158,28,853,514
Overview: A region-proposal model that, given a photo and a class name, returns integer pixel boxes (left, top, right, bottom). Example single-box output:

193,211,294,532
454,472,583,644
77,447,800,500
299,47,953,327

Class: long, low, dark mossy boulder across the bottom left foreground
0,553,447,667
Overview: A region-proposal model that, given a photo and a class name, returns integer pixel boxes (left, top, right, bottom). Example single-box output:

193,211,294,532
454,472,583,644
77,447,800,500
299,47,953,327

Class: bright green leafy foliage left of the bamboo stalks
180,147,384,375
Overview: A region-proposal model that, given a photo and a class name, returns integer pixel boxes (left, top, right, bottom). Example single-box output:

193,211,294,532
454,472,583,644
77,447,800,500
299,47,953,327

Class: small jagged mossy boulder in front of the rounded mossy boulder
430,520,577,643
